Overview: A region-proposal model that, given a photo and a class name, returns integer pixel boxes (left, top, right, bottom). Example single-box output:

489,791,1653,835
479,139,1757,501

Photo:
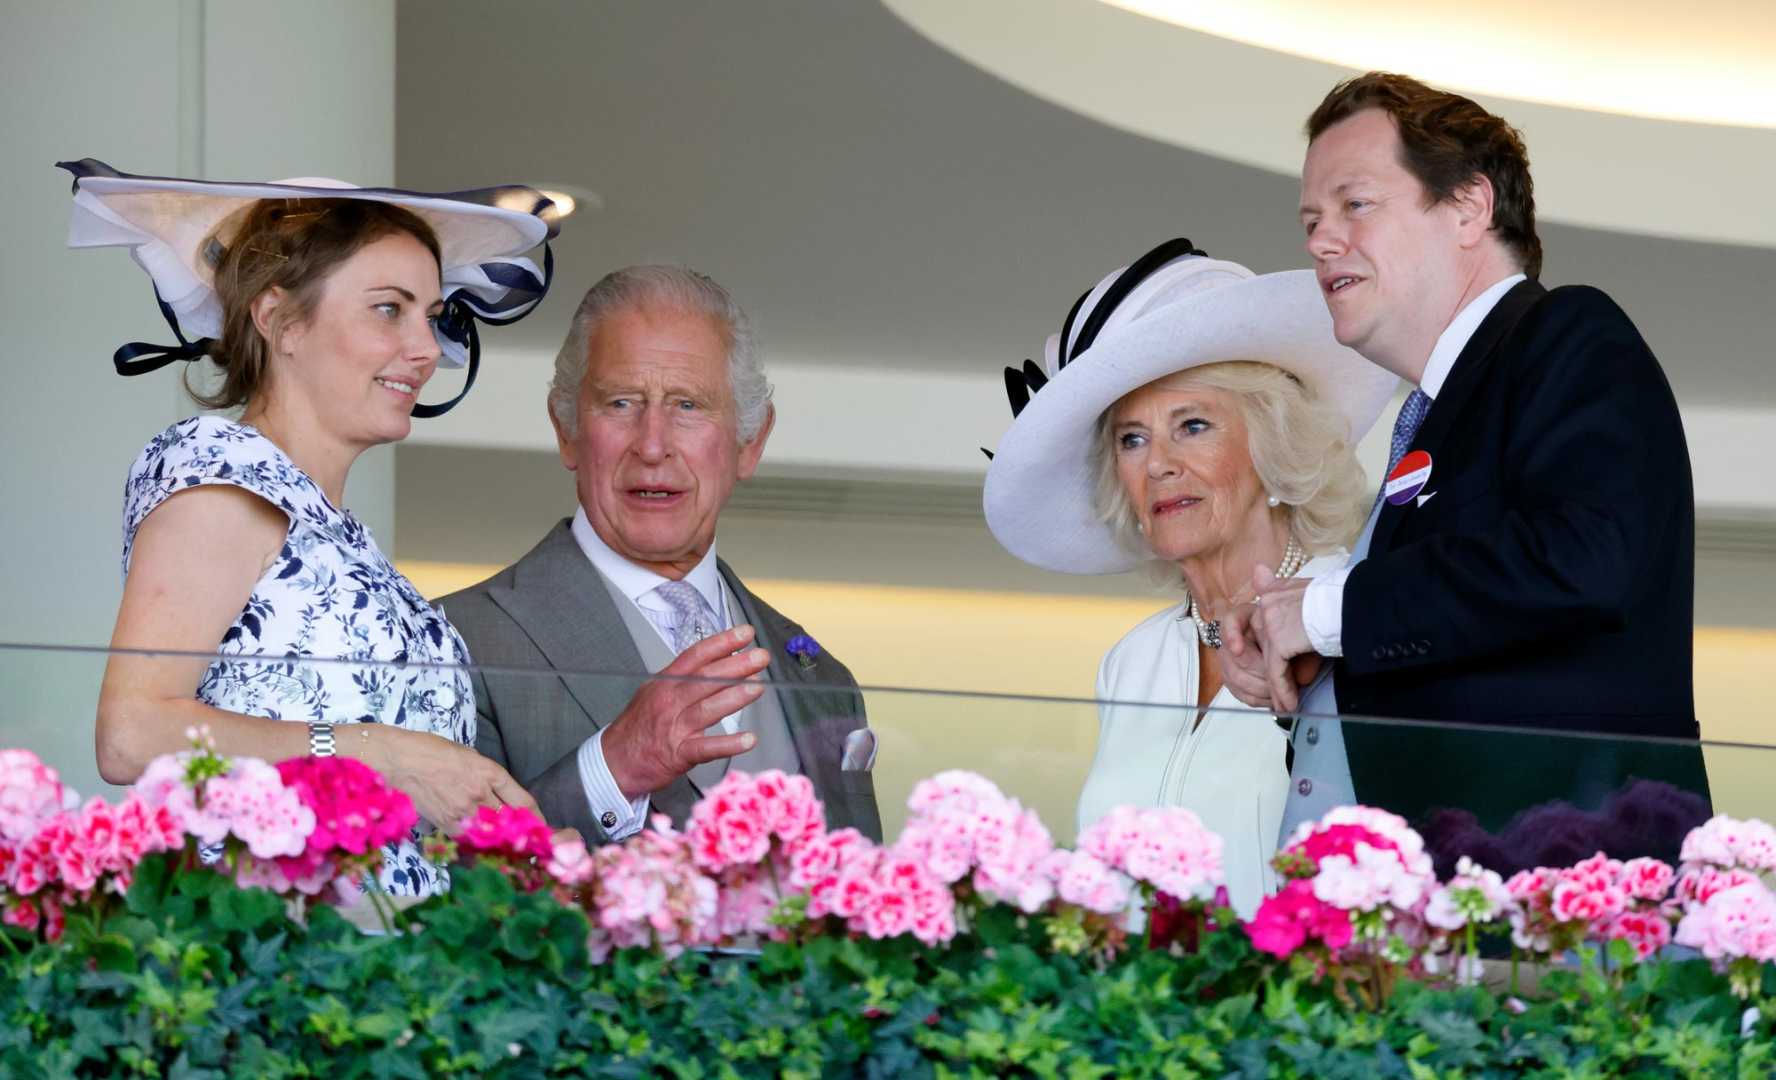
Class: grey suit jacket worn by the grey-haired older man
439,519,883,844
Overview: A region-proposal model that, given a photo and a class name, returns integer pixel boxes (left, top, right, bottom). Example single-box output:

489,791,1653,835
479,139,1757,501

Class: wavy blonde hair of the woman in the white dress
1089,361,1368,581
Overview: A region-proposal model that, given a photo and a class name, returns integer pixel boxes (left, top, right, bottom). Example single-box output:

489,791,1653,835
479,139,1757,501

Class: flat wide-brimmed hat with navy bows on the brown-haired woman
57,158,559,417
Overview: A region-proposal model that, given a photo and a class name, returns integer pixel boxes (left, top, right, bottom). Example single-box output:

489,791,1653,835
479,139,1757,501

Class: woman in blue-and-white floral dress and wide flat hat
62,160,554,895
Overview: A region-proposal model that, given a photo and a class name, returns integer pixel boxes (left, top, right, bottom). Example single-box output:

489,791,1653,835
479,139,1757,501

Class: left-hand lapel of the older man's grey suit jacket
488,520,646,735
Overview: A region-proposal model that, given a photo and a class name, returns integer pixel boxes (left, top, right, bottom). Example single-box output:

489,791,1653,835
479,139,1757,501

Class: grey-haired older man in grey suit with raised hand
440,266,881,842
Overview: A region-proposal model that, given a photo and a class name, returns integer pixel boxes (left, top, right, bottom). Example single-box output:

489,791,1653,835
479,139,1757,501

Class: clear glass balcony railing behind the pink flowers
0,645,1776,891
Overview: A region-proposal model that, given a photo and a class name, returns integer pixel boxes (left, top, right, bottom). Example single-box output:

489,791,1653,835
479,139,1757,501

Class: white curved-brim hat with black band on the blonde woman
982,240,1396,574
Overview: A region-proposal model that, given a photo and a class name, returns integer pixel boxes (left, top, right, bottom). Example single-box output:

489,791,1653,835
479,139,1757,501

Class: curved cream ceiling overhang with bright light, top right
883,0,1776,247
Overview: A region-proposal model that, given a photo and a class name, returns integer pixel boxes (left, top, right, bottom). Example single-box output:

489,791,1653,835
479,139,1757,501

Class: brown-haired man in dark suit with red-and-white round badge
1229,73,1707,863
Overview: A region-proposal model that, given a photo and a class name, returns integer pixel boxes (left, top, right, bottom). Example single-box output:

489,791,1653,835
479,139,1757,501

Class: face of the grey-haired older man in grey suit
556,307,769,579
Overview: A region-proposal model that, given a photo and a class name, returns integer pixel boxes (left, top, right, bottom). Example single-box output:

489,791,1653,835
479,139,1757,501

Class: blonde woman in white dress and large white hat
984,240,1394,915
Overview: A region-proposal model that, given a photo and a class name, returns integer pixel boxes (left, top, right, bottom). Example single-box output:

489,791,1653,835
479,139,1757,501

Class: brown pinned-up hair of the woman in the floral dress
195,199,442,409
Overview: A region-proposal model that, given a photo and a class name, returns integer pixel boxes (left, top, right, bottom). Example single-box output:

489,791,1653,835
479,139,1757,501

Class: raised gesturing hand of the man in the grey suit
604,625,771,799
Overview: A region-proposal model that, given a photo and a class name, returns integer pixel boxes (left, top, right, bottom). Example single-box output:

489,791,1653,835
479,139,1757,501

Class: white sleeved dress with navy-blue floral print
123,416,474,895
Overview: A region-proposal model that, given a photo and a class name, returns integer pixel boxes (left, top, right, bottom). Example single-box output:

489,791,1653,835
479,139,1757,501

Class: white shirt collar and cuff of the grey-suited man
572,508,735,840
